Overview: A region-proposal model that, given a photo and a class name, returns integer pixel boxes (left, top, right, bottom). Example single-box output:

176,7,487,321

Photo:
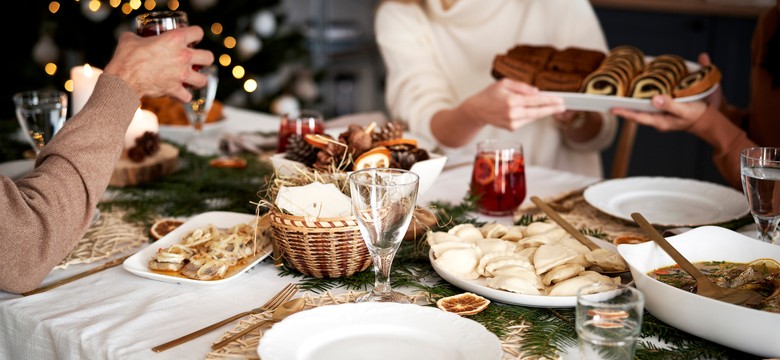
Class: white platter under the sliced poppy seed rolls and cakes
542,56,720,112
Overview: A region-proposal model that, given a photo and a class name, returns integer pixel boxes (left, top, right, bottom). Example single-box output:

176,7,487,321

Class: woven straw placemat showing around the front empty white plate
205,291,526,360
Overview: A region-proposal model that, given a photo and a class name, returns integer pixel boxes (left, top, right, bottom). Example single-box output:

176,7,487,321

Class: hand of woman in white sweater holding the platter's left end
464,78,566,131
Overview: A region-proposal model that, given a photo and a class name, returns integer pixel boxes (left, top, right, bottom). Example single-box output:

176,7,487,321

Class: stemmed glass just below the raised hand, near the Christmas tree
184,65,219,155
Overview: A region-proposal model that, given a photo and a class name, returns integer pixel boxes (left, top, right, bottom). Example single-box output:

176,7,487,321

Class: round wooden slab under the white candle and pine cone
109,142,179,187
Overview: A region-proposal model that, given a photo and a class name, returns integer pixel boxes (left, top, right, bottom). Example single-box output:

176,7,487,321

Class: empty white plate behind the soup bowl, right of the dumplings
583,177,750,227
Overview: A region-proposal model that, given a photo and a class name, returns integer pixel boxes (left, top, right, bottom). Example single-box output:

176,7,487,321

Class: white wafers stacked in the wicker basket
276,181,352,221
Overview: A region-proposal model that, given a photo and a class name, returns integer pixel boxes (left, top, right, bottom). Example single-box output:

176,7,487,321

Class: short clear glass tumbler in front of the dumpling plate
575,283,645,360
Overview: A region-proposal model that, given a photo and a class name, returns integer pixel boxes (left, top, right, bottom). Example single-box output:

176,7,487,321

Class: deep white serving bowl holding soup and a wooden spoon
618,226,780,358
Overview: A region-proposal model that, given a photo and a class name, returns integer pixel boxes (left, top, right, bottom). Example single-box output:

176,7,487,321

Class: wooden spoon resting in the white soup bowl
631,213,763,306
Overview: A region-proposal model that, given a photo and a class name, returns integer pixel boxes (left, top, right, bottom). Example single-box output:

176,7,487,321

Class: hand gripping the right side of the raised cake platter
610,95,707,131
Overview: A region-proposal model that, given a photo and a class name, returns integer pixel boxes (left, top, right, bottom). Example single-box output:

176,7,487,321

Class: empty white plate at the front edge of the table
257,303,504,360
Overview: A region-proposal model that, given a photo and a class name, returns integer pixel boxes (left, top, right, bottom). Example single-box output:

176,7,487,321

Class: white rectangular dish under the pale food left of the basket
122,211,273,286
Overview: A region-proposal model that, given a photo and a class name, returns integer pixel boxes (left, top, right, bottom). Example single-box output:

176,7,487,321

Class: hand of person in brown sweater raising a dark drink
104,26,214,102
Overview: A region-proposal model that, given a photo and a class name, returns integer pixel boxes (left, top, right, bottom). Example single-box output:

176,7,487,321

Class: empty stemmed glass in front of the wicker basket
349,168,420,303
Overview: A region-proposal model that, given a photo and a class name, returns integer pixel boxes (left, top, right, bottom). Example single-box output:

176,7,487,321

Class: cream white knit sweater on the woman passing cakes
375,0,616,176
